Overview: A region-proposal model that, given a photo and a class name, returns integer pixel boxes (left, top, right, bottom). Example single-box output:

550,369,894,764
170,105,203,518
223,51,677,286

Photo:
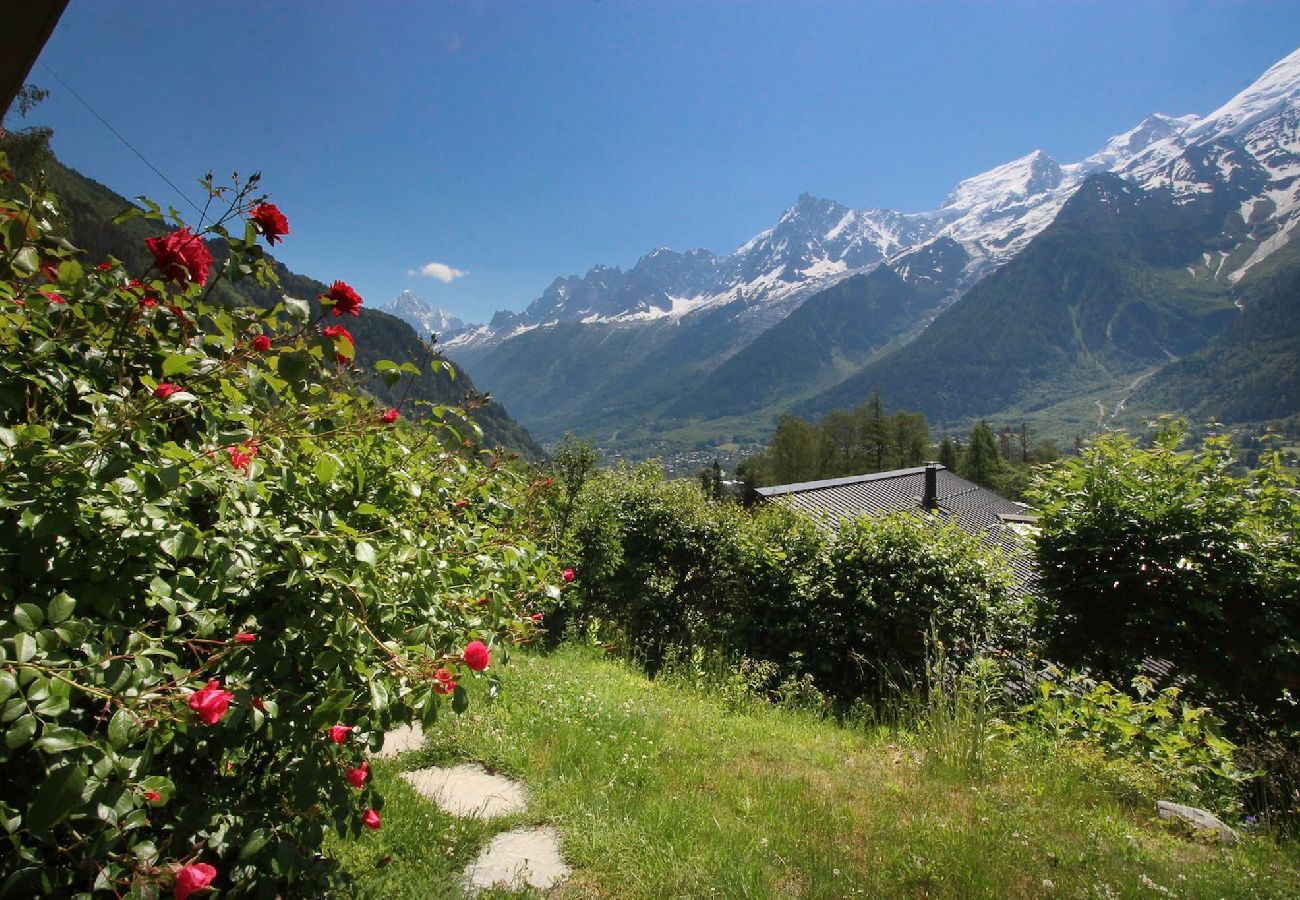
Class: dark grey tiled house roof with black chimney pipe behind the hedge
758,466,1037,593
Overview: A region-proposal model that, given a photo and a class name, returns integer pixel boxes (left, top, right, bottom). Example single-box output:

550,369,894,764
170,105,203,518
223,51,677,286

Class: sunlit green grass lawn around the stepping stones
330,648,1300,899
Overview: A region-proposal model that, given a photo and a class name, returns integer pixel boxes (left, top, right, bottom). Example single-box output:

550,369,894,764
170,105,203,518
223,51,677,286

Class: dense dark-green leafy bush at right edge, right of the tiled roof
1034,424,1300,718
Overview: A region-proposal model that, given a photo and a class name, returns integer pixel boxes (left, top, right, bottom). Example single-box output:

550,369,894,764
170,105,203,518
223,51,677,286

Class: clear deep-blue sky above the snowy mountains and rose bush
10,0,1300,321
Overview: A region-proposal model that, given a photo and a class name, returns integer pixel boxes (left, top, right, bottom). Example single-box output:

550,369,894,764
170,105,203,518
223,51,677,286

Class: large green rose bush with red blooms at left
0,157,559,896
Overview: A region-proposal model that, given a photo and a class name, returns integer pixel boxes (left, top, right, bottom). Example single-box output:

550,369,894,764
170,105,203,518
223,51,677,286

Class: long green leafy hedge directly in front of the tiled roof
569,467,1032,704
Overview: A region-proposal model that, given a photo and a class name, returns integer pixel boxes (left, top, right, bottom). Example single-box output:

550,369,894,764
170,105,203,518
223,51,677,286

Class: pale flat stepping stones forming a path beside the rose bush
377,724,569,896
